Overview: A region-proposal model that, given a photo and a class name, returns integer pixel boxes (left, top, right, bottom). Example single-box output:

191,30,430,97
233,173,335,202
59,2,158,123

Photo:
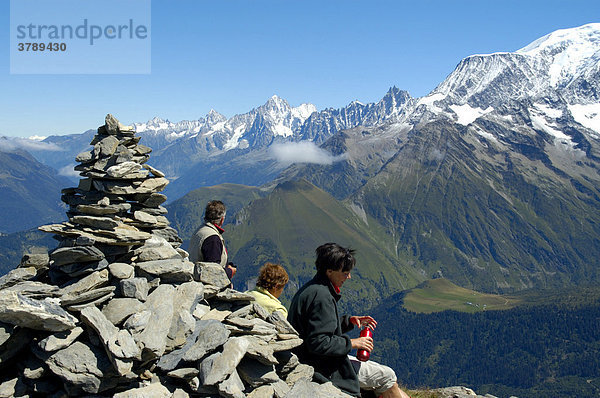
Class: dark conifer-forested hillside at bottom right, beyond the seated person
371,287,600,398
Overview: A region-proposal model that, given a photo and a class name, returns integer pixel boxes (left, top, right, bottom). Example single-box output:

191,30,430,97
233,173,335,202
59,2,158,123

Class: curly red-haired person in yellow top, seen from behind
247,263,290,318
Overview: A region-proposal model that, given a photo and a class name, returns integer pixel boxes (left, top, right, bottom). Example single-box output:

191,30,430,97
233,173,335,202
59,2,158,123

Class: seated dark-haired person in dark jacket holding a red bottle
288,243,409,398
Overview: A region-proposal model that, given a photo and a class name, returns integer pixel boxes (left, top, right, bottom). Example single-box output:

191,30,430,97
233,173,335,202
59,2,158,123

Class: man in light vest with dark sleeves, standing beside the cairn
189,200,236,280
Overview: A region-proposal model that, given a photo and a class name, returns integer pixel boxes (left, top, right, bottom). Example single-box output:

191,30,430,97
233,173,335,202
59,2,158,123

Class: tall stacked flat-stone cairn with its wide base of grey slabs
0,115,348,398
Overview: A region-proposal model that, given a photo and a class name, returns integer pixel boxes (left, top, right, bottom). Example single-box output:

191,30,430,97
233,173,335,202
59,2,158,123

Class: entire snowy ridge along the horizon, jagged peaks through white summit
18,24,600,199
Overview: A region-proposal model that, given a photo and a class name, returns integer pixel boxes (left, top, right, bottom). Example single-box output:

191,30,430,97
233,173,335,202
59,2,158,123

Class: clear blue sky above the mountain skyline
0,0,600,137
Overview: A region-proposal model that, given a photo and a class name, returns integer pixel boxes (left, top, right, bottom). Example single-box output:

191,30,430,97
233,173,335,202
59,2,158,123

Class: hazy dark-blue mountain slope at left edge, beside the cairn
0,151,71,232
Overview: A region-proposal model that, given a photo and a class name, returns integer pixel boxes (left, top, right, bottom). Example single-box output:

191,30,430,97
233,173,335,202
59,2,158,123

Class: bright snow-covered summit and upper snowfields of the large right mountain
411,23,600,139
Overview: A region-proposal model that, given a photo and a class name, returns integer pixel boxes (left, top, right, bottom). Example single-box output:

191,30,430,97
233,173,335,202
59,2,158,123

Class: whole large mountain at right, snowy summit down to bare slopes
275,24,600,291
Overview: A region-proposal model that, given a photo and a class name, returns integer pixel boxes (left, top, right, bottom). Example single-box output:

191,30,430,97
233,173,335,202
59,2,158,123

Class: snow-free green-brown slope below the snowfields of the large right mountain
352,120,600,292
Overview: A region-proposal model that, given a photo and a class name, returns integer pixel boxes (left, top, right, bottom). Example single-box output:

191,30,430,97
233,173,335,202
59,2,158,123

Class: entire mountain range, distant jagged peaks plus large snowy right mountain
1,24,600,298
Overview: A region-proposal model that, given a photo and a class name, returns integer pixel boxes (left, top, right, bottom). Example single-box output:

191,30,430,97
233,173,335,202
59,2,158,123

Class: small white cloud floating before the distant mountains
271,141,347,165
